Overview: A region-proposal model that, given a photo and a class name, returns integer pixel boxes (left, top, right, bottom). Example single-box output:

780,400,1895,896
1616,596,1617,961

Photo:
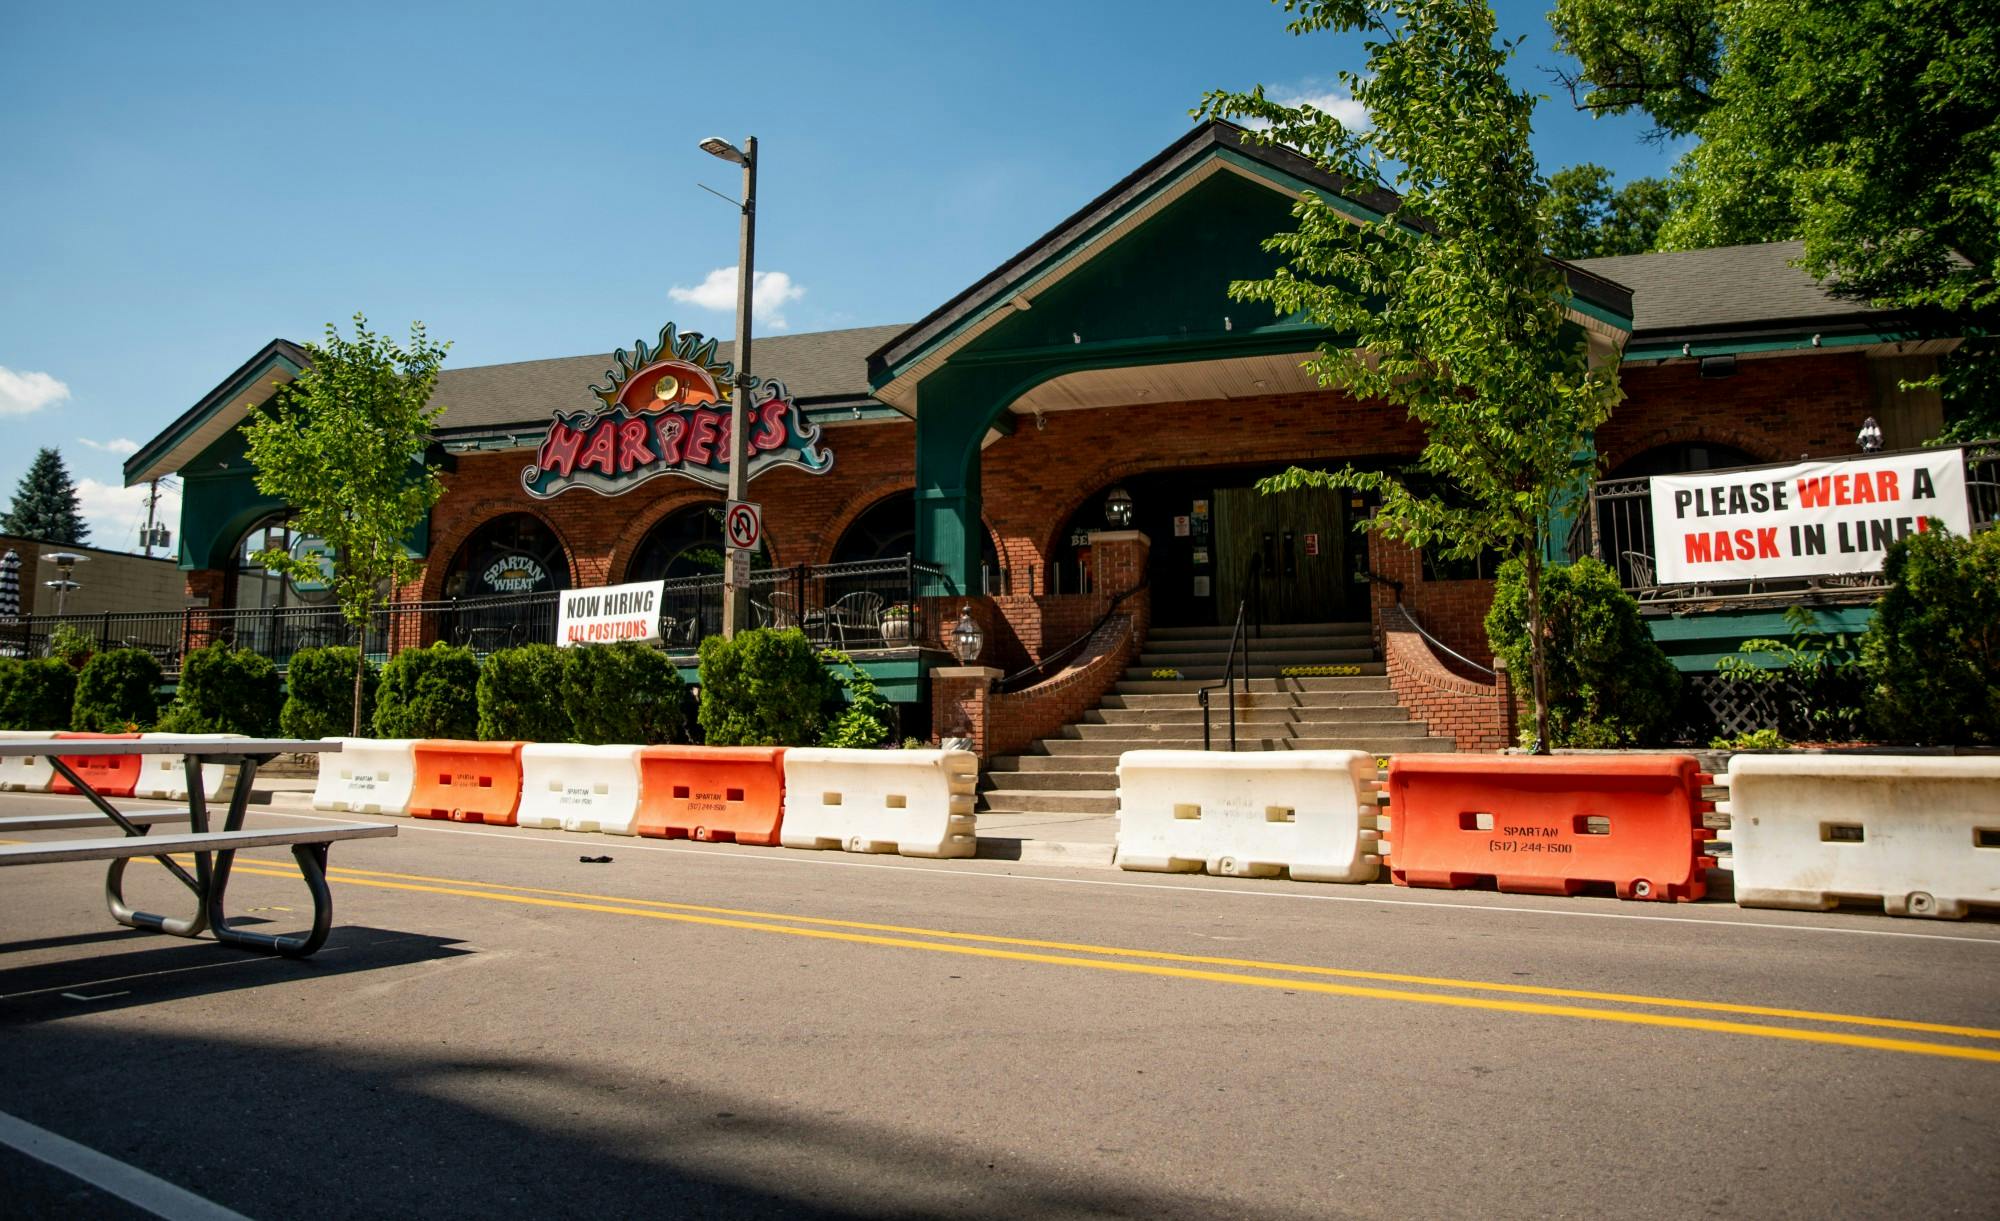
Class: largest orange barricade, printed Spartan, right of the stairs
1384,755,1714,901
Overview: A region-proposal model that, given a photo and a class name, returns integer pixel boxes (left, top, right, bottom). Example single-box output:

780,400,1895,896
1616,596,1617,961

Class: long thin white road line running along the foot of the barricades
256,807,2000,949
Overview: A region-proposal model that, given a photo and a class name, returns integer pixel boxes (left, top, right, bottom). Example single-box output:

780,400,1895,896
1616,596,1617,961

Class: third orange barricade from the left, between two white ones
632,747,784,847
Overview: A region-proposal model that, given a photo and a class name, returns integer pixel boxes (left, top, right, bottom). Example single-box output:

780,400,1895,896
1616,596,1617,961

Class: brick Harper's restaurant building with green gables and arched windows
126,122,1968,751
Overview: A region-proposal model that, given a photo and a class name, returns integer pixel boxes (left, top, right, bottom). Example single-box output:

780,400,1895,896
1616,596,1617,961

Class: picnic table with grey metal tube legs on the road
0,737,396,959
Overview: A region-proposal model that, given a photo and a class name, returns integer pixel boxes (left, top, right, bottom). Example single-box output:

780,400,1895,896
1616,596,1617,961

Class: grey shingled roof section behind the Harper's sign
432,322,908,436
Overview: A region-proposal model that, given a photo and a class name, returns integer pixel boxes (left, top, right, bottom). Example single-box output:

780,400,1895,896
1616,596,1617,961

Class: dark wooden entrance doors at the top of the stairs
1214,488,1362,623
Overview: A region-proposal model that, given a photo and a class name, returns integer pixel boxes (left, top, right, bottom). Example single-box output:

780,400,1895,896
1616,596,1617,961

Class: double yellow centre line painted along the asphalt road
215,857,2000,1063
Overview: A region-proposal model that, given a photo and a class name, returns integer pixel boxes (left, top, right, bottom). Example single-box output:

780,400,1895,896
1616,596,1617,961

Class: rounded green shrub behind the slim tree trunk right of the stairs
1486,558,1680,747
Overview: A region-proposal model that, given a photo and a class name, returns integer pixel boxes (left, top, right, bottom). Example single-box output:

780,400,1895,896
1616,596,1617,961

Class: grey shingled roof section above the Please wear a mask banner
1572,242,1884,340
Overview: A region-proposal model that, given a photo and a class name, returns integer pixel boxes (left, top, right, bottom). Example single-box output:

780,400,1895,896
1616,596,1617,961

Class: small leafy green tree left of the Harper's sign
244,314,450,737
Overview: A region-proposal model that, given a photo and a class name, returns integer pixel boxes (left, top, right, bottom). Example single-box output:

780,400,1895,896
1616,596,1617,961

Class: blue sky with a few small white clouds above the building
0,0,1672,546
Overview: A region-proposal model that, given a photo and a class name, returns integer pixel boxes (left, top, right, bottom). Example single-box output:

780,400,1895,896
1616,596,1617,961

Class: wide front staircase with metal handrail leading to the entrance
978,623,1452,815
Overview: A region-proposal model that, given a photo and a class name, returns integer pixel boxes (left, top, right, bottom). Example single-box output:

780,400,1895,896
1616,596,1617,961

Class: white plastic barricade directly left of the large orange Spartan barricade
1118,751,1382,883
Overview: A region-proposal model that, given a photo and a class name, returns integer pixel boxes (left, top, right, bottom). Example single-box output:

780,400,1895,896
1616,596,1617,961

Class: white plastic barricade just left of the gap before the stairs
778,747,980,857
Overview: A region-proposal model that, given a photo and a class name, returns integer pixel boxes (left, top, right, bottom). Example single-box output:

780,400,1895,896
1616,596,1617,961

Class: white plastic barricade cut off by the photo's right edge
1716,755,2000,921
